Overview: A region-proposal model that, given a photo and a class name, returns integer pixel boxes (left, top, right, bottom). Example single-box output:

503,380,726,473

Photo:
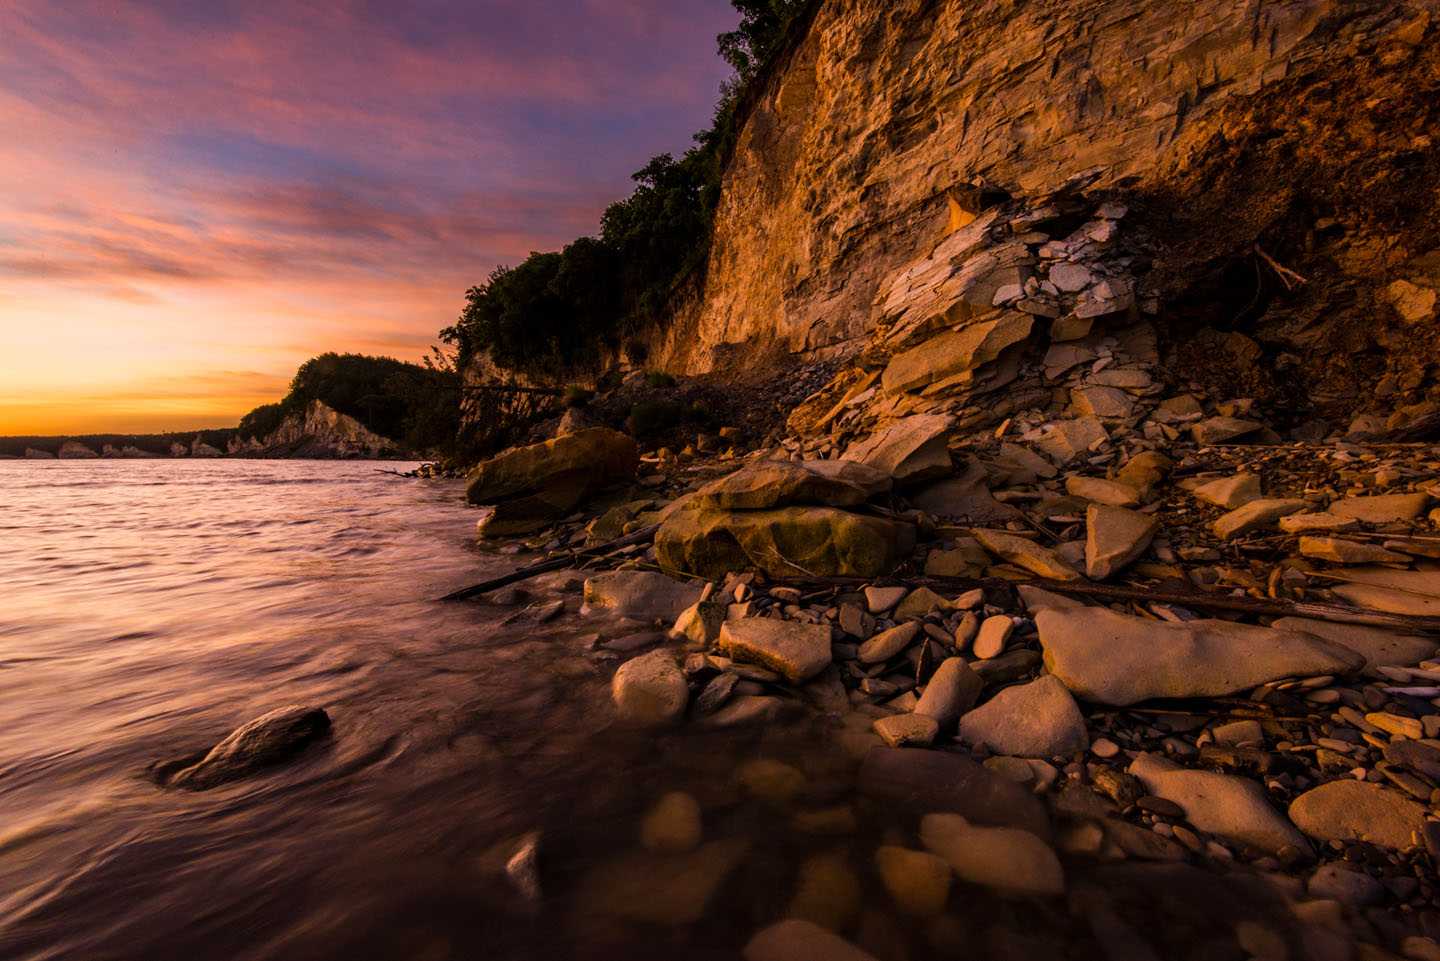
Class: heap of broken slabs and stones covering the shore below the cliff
460,177,1440,961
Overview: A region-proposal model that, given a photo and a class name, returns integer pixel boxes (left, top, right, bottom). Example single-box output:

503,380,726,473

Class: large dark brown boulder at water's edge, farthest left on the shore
465,426,639,537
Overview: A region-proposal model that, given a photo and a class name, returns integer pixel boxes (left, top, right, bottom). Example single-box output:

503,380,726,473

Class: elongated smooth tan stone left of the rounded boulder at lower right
1129,754,1309,854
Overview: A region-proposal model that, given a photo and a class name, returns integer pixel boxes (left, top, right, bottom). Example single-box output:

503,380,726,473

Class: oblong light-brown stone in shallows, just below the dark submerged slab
920,814,1066,896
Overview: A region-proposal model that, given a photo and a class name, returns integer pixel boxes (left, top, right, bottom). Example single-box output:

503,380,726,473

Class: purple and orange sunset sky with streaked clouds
0,0,737,435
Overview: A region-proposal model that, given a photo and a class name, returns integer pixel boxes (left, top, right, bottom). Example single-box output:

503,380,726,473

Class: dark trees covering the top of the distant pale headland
238,353,459,450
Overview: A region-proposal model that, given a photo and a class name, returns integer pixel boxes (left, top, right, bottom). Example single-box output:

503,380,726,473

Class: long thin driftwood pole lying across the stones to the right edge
782,576,1440,633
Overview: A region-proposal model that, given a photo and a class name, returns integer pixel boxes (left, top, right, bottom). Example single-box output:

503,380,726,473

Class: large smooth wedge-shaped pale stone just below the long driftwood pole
1025,602,1364,706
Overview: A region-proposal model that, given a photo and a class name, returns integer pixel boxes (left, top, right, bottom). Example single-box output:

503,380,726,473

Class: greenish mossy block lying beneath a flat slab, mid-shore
655,507,916,581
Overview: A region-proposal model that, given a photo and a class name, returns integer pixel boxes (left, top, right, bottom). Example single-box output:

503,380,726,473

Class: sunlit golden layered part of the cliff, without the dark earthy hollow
651,0,1430,397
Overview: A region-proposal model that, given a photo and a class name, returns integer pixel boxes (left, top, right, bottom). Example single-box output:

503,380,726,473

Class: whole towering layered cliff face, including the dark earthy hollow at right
651,0,1440,429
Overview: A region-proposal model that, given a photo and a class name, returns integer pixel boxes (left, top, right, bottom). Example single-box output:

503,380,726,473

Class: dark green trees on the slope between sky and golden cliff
441,0,806,375
